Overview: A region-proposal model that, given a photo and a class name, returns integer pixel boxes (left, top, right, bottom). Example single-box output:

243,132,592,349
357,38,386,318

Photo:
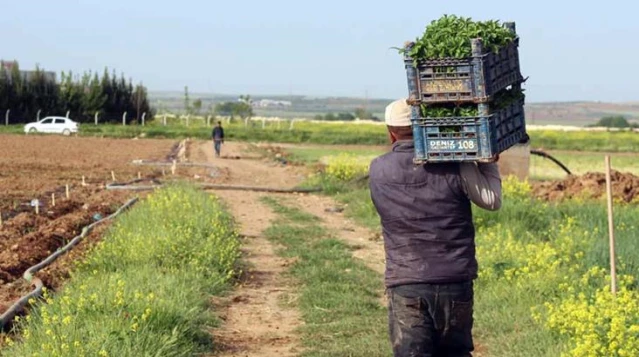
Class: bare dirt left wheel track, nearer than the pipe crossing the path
208,191,301,357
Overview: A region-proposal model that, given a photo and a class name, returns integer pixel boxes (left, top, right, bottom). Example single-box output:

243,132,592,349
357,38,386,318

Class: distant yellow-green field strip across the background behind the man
0,120,639,152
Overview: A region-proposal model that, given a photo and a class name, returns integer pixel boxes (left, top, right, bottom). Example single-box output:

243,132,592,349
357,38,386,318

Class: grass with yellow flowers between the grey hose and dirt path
2,186,239,357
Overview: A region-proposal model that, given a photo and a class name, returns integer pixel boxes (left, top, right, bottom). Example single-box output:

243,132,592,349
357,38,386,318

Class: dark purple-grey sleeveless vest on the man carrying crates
370,141,477,288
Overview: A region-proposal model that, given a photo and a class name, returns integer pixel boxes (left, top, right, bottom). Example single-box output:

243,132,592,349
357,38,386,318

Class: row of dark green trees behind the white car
0,65,154,123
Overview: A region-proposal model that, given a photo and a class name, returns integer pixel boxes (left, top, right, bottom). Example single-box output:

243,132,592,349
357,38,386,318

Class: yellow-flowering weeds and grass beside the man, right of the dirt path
324,154,639,357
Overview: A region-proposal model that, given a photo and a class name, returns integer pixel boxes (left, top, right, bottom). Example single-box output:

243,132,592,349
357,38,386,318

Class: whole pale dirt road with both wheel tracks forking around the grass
187,141,384,357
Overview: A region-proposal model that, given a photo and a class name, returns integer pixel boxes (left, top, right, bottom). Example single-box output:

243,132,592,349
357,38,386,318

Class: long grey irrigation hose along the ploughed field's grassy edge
0,197,138,330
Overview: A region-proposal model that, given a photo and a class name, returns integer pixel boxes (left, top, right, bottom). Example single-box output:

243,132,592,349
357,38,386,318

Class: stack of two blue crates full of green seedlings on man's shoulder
402,16,528,164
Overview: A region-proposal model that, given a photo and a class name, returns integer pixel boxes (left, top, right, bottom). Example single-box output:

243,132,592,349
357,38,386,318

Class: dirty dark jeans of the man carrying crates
387,281,474,357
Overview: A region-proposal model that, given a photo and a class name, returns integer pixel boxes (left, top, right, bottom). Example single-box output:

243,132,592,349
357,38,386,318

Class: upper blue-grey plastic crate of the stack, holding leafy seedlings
404,22,524,104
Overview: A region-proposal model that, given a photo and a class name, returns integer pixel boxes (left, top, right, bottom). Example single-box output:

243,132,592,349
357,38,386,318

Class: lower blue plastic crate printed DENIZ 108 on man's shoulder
412,100,528,164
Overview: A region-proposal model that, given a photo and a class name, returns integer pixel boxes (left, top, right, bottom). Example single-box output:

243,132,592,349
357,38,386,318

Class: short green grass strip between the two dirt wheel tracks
264,199,391,357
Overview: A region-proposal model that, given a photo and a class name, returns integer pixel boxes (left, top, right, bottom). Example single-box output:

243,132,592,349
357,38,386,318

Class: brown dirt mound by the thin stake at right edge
533,170,639,203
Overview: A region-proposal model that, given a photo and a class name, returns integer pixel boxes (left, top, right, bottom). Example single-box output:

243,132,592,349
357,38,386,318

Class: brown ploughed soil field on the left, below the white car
0,135,212,320
